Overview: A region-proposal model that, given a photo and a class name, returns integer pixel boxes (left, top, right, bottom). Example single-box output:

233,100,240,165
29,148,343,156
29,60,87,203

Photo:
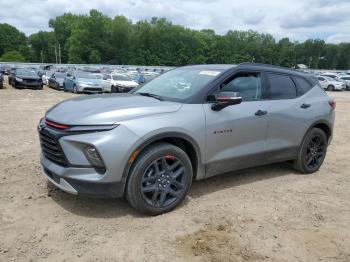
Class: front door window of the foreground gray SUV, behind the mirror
220,72,262,101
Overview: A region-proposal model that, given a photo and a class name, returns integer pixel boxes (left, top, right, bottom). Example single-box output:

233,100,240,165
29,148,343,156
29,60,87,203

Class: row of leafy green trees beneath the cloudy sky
0,10,350,69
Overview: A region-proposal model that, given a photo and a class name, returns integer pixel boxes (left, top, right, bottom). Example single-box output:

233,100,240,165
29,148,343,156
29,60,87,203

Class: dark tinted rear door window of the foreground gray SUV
268,74,297,99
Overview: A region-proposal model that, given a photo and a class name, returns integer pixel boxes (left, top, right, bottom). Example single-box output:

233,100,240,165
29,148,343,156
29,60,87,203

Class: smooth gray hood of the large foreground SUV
46,94,181,125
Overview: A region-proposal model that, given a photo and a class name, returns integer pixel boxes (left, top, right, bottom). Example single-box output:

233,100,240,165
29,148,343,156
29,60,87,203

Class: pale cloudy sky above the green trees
0,0,350,43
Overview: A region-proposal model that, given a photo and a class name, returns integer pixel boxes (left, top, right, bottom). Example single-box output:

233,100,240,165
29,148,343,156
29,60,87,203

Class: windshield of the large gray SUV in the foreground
135,67,222,101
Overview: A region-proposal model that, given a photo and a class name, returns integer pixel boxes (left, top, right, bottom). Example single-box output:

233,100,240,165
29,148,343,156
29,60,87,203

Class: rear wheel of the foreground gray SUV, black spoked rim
293,128,328,174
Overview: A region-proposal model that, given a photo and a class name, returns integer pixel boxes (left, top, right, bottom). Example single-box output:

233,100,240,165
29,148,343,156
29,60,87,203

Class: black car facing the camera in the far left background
10,69,43,89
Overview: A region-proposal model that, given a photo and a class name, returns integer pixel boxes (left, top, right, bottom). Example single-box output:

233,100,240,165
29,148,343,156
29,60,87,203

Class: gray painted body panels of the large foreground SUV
42,65,334,196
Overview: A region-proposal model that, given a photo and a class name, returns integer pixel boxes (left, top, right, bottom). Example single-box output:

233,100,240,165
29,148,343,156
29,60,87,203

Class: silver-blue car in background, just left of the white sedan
63,71,103,94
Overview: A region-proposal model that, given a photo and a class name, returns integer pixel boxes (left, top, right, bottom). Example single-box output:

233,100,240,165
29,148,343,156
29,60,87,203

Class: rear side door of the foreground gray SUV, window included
265,73,314,162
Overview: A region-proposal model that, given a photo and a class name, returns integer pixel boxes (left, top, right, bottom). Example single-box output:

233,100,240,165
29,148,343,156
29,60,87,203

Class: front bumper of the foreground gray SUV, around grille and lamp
41,125,139,198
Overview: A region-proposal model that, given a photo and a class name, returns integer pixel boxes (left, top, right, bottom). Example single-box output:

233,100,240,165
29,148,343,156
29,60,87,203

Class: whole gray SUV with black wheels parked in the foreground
38,63,335,215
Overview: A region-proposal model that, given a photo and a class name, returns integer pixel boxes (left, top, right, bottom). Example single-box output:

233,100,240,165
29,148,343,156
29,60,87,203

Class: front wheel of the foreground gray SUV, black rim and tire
126,143,193,215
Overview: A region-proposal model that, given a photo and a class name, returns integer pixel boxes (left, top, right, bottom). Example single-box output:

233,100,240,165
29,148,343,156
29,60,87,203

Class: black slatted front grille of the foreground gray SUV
39,128,68,166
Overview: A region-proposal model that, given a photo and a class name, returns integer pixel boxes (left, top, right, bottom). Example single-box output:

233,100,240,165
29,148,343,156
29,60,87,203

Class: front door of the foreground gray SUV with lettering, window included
204,71,268,176
